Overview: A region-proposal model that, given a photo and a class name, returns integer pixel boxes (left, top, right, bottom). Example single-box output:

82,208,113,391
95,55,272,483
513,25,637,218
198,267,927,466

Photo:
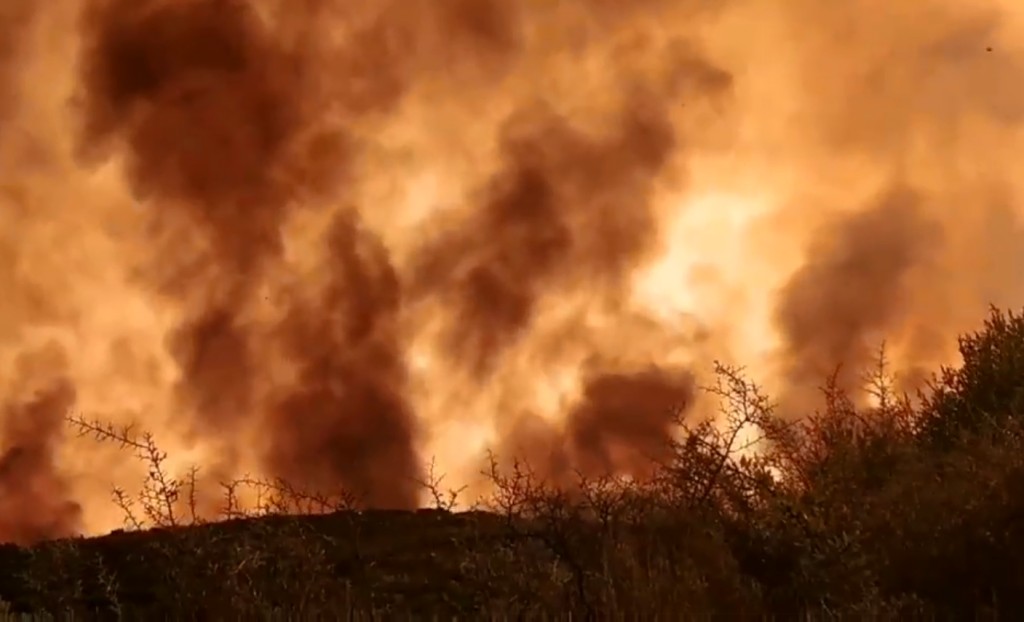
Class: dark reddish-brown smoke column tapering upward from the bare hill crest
268,212,422,509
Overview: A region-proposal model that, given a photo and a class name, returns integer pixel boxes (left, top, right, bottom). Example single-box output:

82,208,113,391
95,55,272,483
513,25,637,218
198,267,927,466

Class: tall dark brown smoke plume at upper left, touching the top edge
75,1,319,442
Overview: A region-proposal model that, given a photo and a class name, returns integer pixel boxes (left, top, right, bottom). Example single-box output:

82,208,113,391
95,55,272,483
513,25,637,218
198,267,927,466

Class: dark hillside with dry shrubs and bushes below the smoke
0,310,1024,619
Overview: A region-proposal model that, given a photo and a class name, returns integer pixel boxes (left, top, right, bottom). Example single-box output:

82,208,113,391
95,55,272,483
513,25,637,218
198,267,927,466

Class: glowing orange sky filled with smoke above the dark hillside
0,0,1024,541
